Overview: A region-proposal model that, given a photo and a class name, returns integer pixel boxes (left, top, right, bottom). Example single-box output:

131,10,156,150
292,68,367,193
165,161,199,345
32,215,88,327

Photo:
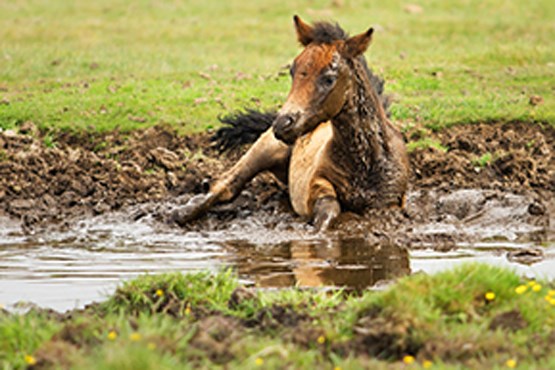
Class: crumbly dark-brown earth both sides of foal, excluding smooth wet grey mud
0,123,555,234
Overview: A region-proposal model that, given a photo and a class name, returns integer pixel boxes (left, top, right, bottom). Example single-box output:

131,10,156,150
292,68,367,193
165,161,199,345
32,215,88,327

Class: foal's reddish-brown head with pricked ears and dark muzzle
273,16,374,144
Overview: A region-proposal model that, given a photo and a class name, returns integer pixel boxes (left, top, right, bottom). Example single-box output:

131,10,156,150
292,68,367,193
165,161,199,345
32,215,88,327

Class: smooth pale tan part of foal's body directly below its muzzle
289,122,335,217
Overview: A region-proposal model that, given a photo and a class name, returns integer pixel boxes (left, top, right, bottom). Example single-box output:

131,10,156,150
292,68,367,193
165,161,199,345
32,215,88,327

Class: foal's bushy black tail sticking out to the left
211,109,277,152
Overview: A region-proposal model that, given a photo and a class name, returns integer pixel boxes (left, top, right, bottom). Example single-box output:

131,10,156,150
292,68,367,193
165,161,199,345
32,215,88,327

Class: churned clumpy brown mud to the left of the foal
0,123,220,227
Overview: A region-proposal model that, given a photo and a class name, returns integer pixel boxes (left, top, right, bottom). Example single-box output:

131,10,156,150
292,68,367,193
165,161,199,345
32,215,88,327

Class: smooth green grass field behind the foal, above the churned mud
0,0,555,133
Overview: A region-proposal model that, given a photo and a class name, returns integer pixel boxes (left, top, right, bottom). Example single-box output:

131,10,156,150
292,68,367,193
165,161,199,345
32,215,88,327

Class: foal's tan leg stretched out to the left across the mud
171,128,291,226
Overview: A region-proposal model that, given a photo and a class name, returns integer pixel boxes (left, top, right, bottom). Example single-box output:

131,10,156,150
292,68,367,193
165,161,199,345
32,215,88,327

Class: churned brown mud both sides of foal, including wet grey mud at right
0,122,555,246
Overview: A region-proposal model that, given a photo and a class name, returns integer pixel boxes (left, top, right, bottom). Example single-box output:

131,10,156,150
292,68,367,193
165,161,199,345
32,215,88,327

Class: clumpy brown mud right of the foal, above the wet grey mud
408,122,555,192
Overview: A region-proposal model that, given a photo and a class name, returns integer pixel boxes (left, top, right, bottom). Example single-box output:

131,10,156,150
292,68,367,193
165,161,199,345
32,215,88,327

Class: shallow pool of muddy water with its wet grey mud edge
0,190,555,311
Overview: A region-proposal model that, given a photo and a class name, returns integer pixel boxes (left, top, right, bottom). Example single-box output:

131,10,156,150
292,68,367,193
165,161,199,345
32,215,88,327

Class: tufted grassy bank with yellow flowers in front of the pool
0,265,555,369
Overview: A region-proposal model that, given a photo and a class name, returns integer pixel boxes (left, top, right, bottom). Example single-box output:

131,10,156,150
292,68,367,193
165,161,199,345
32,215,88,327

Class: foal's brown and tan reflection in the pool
227,238,410,290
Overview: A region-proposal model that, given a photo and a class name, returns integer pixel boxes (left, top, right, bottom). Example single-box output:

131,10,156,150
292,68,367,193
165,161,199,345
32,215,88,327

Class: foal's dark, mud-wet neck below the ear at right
333,63,387,173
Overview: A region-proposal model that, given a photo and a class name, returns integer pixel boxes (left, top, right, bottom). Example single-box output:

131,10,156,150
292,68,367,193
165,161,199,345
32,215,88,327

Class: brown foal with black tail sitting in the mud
171,15,409,230
